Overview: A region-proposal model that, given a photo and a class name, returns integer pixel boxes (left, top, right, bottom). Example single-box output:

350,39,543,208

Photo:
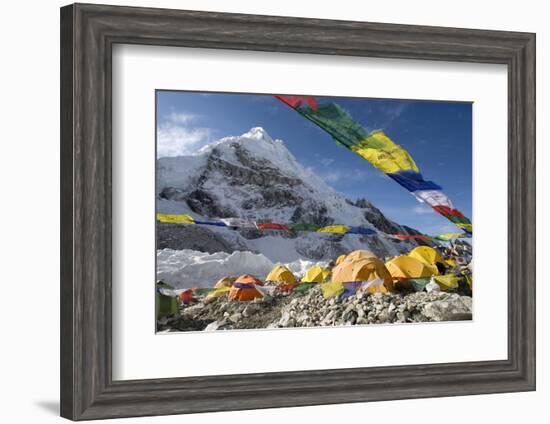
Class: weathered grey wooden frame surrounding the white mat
60,4,535,420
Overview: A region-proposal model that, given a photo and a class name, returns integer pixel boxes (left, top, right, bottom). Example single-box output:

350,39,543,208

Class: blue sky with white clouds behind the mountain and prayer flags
157,91,472,234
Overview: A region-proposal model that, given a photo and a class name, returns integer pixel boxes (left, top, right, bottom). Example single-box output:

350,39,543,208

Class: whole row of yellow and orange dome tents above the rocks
156,246,472,317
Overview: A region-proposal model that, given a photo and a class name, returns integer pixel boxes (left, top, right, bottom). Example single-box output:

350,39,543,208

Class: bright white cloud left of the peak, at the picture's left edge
157,112,213,158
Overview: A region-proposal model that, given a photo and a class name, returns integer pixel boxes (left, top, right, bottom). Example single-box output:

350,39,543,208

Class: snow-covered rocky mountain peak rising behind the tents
156,127,430,262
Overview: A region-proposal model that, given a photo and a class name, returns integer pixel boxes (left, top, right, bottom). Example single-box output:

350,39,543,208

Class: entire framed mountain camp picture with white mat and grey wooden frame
61,4,535,420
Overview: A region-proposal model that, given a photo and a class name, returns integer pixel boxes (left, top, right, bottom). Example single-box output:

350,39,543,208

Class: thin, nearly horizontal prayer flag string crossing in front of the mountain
157,213,470,241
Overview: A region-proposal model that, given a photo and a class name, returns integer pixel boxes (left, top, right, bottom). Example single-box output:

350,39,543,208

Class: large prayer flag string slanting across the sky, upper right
275,96,472,234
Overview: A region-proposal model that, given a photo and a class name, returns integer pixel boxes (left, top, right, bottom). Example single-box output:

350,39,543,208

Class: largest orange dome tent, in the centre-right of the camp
332,255,393,292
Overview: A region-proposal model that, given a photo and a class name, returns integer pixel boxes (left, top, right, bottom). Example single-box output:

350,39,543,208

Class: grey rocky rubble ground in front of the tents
157,287,472,332
